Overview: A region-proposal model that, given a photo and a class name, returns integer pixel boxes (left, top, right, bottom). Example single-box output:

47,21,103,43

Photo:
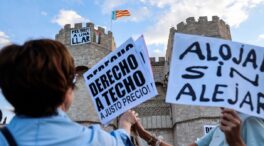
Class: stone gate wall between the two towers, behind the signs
134,81,174,145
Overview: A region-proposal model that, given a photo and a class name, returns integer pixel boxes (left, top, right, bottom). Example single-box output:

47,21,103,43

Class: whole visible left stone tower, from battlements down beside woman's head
56,23,115,129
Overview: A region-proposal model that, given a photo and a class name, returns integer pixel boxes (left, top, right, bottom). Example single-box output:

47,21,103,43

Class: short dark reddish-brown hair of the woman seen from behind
0,39,74,117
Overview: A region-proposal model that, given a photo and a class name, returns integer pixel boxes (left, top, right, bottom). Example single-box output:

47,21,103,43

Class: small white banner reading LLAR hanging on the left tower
71,27,91,45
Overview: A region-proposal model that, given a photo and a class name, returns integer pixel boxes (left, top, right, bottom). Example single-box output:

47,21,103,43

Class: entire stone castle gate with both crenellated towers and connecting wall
56,16,231,146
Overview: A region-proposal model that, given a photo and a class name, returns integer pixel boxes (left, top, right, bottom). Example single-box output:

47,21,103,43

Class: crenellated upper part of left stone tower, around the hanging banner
55,22,115,68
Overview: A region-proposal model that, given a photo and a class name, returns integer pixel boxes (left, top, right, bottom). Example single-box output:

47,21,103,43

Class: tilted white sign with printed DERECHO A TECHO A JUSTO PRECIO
83,39,157,124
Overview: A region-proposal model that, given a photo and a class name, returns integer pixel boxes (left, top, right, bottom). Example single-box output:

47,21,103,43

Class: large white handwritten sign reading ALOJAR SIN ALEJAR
166,33,264,118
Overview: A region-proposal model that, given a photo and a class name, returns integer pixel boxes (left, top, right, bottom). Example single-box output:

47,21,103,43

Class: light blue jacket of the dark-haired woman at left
0,110,133,146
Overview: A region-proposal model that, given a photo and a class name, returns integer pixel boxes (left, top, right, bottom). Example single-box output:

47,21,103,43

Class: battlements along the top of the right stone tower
177,16,229,30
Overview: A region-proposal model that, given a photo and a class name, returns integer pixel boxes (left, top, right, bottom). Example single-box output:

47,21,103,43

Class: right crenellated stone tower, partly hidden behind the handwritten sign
164,16,231,146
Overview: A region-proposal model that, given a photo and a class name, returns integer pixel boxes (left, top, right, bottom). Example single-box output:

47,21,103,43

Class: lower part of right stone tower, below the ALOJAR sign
172,105,220,146
